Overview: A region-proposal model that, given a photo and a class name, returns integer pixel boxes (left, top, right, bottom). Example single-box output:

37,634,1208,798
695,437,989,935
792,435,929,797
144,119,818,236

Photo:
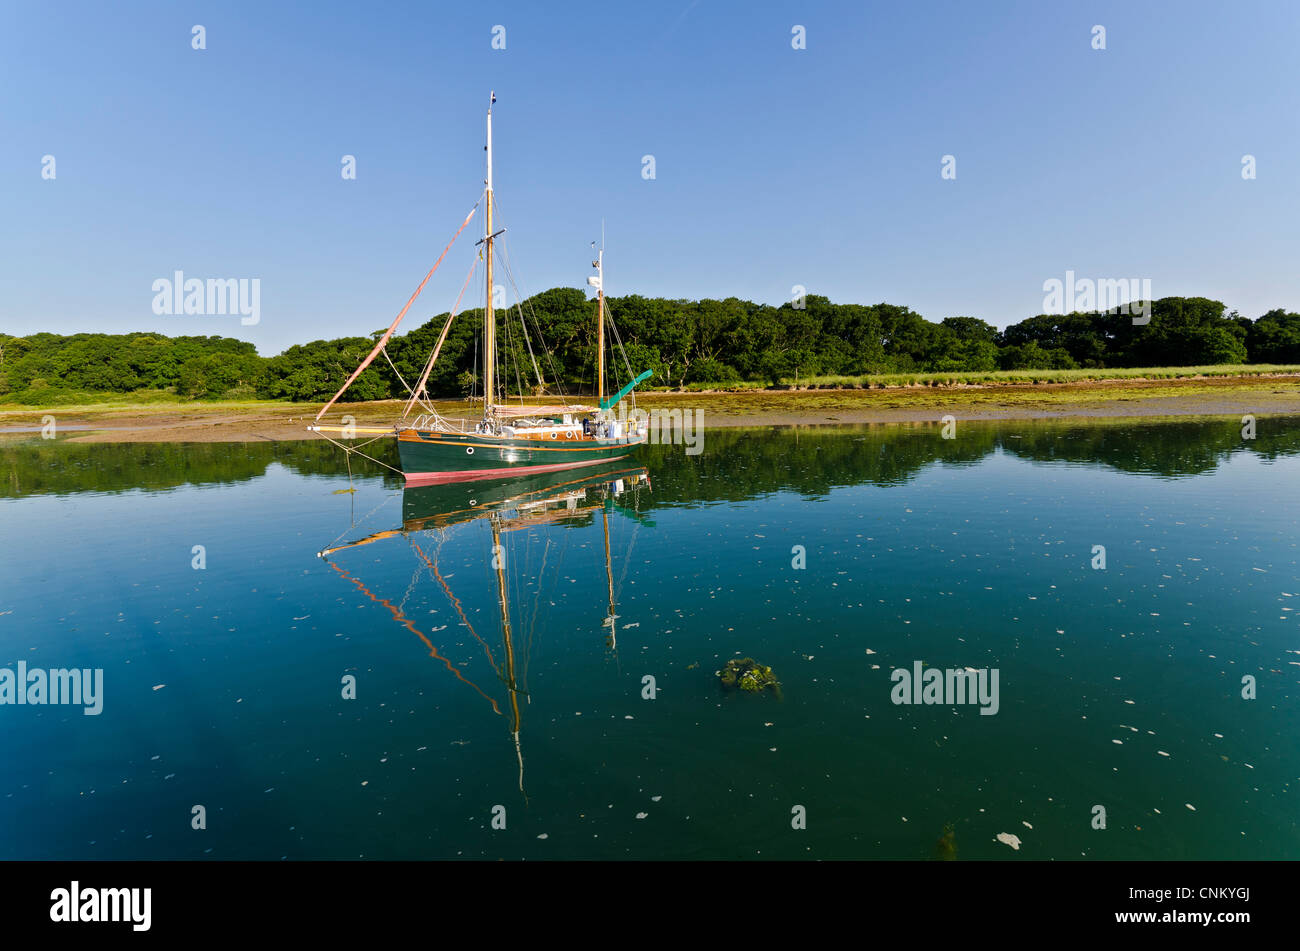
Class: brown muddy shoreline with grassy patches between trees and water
0,375,1300,443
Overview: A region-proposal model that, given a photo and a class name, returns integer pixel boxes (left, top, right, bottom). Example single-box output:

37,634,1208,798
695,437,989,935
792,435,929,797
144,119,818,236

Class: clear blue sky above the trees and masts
0,0,1300,353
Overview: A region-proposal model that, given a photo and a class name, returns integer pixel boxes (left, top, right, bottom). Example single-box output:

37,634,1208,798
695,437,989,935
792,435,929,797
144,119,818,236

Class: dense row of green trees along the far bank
0,287,1300,404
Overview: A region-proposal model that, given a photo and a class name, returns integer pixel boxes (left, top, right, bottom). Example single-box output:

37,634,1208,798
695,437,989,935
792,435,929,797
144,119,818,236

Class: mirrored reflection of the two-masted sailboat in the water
319,463,650,798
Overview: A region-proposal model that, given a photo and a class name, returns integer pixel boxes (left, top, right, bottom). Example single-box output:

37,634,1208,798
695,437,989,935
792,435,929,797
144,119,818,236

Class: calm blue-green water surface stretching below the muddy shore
0,420,1300,860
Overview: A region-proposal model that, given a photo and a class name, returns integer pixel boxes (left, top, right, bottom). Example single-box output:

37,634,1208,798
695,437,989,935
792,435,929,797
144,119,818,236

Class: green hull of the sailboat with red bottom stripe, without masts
398,429,645,485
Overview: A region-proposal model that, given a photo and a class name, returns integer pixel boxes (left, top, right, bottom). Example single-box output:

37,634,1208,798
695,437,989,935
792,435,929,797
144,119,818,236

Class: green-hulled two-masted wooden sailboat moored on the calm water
308,94,651,485
